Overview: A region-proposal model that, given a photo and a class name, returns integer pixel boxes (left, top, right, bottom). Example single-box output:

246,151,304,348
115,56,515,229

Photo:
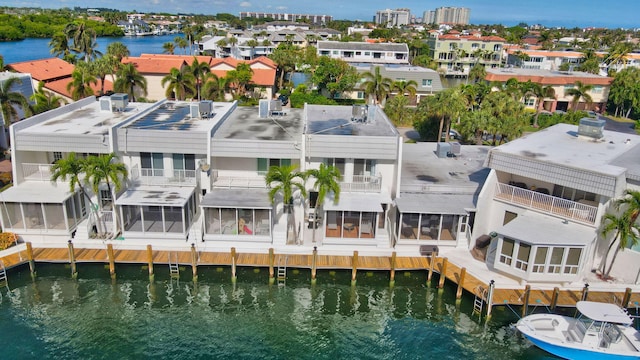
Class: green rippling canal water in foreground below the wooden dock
0,264,551,360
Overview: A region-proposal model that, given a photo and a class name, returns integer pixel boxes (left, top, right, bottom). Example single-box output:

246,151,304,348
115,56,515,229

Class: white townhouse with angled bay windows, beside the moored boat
469,119,640,283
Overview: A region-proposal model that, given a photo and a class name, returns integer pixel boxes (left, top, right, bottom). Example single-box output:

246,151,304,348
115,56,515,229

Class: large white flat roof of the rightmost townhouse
491,124,640,176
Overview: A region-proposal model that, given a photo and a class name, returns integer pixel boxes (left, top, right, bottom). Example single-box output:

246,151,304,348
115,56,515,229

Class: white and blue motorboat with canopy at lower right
516,301,640,360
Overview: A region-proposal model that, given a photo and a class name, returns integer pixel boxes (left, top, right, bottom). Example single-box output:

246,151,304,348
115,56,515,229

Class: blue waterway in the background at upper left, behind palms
0,34,189,64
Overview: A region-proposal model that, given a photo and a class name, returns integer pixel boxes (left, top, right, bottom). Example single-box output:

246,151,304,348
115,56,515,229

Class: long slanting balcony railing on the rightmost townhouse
495,183,598,224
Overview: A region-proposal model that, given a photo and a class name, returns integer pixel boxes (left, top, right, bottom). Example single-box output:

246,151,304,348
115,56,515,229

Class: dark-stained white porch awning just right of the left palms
116,186,195,207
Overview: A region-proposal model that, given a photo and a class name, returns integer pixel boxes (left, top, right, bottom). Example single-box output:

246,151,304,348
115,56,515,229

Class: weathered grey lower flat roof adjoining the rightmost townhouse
400,142,491,197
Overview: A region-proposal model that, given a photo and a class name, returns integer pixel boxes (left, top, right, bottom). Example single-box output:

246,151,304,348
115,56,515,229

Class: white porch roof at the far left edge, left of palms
0,181,73,204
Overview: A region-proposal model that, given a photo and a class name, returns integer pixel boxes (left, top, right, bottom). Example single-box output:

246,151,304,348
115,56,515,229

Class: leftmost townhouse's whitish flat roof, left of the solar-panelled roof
18,97,154,136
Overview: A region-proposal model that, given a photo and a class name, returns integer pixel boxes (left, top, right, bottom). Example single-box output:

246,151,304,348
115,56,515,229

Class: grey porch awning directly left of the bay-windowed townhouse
396,193,477,215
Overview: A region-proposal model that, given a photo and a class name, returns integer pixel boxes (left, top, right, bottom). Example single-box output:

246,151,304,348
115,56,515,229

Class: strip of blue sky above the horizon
2,0,640,28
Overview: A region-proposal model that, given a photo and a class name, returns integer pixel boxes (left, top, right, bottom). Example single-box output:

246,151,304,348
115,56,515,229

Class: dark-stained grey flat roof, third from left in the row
214,106,303,141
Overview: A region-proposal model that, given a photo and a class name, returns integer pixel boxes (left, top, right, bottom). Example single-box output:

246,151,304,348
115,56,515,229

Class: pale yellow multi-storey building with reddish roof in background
427,31,505,76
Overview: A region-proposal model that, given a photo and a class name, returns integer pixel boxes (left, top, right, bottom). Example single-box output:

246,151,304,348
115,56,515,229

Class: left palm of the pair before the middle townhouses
265,165,306,243
